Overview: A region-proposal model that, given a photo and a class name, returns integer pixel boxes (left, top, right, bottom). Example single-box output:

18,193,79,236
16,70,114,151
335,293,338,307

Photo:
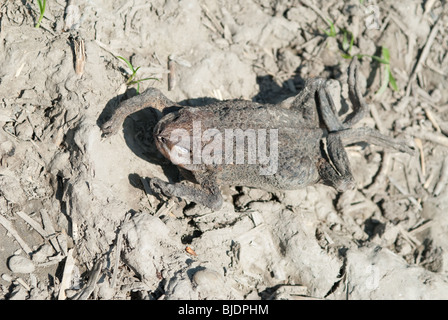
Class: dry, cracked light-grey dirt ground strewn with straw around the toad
0,0,448,299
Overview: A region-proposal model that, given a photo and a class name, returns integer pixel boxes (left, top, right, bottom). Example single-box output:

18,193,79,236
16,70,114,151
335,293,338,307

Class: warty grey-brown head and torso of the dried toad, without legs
154,101,326,190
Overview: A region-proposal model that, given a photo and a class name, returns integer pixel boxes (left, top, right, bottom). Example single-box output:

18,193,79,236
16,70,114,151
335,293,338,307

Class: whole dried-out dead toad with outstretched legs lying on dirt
101,58,414,209
